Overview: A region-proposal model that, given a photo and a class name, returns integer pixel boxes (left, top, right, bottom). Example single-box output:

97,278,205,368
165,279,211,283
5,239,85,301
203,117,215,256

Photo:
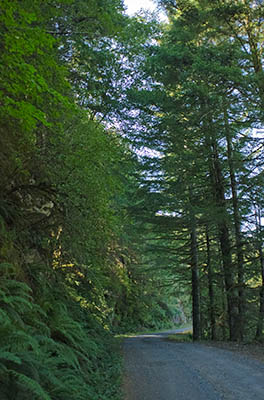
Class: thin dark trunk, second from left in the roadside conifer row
206,226,216,340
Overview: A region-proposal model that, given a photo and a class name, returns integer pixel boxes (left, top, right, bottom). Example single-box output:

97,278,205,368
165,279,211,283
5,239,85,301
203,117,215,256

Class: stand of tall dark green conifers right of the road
121,0,264,340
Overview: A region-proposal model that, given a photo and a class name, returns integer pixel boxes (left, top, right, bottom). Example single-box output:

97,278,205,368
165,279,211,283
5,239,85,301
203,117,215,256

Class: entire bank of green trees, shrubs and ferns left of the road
0,0,179,400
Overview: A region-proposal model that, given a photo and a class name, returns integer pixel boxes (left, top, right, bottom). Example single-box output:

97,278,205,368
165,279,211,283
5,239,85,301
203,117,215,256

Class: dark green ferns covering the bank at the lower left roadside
0,264,120,400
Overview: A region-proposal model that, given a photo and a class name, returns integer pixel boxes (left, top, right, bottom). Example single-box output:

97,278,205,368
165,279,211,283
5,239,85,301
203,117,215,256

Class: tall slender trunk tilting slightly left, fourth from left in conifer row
224,106,245,340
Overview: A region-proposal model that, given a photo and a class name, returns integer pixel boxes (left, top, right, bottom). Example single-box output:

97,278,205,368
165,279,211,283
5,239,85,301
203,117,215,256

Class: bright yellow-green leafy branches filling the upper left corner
0,1,68,182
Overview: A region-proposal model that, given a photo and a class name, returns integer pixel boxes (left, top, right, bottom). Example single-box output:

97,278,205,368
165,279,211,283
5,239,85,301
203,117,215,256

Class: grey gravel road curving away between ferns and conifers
123,330,264,400
